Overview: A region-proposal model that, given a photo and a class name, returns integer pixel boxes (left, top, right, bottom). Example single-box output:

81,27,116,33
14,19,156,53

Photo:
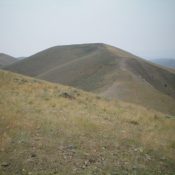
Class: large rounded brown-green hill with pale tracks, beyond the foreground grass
6,44,175,114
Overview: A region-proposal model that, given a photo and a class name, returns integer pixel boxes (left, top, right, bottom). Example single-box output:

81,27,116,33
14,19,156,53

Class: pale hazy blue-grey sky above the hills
0,0,175,58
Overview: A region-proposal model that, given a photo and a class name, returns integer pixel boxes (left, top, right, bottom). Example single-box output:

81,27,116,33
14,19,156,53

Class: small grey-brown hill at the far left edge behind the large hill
0,53,17,67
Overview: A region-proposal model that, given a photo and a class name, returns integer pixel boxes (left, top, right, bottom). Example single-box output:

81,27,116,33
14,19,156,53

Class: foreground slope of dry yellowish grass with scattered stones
0,71,175,175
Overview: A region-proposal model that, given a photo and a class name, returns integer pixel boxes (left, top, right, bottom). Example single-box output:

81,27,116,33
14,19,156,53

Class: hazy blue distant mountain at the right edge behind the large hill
150,58,175,68
